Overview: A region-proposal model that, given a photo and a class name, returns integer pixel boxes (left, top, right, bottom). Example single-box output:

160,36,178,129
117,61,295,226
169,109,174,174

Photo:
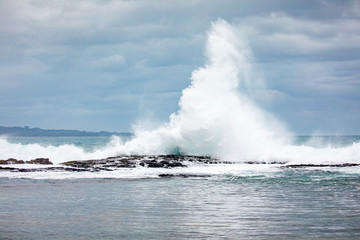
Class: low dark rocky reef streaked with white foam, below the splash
0,155,360,175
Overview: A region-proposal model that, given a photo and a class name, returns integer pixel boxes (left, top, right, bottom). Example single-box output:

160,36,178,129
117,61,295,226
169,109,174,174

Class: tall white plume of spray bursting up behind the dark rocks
115,20,290,160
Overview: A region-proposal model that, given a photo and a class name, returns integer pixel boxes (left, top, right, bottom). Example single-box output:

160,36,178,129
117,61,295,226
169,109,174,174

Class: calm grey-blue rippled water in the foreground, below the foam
0,172,360,239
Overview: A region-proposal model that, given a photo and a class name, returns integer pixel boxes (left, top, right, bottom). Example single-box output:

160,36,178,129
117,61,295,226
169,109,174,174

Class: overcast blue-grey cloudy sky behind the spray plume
0,0,360,134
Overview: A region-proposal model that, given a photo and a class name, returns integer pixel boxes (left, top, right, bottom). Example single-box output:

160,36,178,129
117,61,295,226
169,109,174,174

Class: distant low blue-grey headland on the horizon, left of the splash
0,126,133,137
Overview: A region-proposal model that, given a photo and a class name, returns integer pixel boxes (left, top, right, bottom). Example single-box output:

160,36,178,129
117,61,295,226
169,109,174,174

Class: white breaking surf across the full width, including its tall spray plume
0,19,360,171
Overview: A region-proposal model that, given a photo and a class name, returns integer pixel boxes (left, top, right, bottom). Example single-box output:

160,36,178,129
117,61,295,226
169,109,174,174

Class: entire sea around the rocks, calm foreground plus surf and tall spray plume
0,20,360,239
